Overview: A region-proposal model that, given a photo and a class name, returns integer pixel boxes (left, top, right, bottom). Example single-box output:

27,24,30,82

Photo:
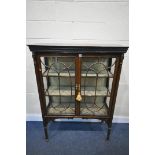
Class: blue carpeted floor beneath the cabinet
26,121,129,155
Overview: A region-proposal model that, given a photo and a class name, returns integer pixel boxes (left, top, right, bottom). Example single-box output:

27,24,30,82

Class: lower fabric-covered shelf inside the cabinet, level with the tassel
45,86,110,96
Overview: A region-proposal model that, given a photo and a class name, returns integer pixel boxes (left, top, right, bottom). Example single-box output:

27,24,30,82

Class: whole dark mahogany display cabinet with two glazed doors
28,45,128,140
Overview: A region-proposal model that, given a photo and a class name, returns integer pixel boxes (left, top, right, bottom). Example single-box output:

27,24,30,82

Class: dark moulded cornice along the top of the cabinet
28,44,128,54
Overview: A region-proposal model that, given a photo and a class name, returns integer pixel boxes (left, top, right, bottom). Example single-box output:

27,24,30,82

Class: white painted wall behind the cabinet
26,0,129,122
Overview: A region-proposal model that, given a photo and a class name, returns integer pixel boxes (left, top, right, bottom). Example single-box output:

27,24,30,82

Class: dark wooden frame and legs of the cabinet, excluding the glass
28,45,128,140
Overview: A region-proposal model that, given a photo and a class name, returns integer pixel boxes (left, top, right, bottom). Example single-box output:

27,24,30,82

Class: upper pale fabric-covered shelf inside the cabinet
42,71,113,78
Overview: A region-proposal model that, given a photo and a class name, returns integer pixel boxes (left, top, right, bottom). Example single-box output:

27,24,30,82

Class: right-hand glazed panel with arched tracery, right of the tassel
80,56,116,116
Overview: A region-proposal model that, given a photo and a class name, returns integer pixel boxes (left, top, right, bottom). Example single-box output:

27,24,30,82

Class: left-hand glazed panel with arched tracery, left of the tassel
41,56,75,115
